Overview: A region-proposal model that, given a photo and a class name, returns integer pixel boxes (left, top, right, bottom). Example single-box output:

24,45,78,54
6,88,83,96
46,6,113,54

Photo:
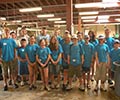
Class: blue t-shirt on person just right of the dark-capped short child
25,44,39,63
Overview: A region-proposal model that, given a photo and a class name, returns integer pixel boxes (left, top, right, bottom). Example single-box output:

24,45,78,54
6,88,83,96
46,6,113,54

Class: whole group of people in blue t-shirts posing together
0,27,120,94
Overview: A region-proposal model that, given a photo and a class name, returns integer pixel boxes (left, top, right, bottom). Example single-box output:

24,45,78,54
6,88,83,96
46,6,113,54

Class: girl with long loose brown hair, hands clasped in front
49,36,63,89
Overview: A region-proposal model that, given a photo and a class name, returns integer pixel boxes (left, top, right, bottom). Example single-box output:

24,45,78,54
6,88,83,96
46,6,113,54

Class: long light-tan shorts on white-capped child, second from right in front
95,63,107,82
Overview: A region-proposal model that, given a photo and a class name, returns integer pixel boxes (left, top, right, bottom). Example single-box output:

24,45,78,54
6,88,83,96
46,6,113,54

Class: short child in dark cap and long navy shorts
18,38,28,86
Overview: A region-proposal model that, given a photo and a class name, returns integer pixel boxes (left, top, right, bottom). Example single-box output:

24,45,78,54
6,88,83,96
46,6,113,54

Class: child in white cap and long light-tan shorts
95,35,110,91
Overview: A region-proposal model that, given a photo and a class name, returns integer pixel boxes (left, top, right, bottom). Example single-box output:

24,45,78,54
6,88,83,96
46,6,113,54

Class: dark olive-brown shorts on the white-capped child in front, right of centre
68,65,82,78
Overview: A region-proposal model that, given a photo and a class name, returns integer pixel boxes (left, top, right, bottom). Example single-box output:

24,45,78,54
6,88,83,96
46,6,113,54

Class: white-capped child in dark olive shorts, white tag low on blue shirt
66,34,84,90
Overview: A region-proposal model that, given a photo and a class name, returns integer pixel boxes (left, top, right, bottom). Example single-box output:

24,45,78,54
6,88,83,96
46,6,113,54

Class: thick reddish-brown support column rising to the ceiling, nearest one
66,0,73,33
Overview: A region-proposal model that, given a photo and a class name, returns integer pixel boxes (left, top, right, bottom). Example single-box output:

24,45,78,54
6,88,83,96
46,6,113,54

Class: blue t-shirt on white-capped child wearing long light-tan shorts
96,43,109,62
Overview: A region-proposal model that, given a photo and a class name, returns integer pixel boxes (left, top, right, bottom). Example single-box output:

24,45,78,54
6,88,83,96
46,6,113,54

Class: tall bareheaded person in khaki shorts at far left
0,28,18,91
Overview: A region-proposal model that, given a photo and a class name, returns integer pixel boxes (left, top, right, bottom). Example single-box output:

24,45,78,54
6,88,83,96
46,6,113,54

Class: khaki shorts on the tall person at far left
2,60,17,77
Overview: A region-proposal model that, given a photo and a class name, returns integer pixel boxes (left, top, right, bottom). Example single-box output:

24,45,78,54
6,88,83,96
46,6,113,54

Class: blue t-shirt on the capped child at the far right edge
110,48,120,69
